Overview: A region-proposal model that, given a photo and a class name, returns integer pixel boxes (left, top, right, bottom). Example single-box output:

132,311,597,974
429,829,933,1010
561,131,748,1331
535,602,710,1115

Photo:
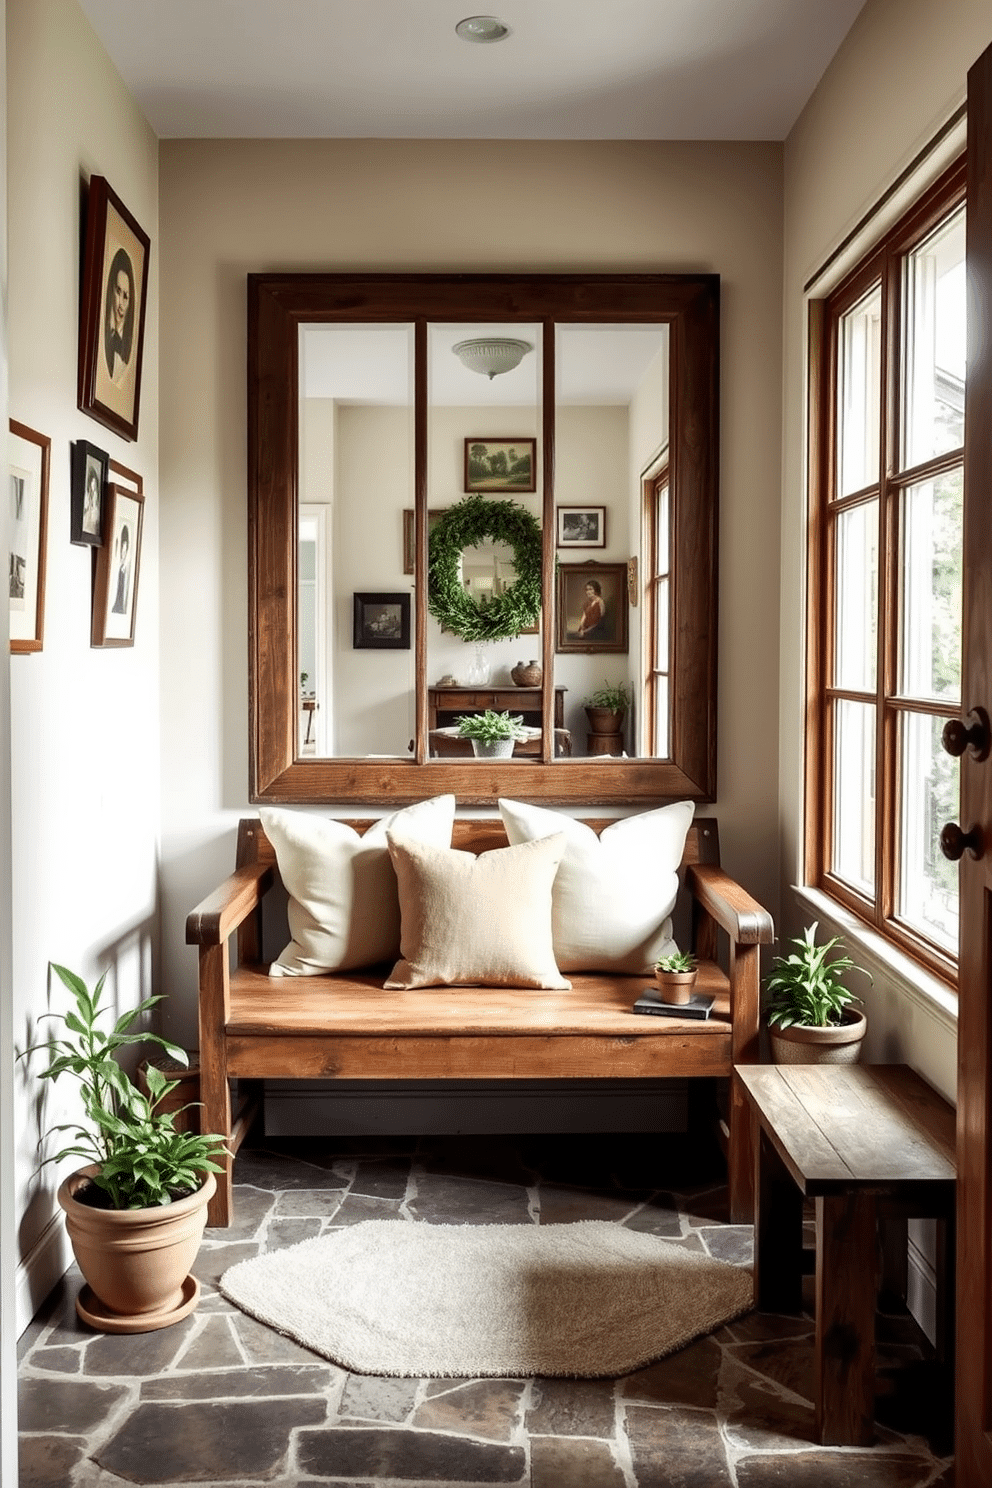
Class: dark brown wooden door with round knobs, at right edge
949,37,992,1488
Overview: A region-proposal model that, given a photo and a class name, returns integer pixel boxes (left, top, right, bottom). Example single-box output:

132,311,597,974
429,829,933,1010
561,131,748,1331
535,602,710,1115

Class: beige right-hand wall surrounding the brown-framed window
779,0,992,1098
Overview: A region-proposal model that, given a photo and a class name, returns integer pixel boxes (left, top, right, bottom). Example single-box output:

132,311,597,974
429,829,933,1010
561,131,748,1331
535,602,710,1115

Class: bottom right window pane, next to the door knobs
897,713,959,955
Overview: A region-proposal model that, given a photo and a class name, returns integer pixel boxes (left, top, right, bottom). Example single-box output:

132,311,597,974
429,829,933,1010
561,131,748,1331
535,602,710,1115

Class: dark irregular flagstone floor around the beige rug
19,1135,953,1488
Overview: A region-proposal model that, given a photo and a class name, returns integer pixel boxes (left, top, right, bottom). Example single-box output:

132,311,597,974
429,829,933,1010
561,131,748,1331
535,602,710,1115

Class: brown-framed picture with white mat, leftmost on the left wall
7,418,52,653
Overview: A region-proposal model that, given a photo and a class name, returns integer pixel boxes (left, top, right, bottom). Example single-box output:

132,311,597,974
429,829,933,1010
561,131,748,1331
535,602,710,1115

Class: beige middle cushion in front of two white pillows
385,832,571,990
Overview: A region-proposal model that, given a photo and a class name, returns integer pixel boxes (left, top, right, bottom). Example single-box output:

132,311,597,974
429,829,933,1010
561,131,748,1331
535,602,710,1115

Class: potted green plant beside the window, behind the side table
764,923,872,1064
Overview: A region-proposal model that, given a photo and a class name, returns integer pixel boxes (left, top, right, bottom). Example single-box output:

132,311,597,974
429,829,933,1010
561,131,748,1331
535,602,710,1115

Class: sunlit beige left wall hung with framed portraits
6,0,159,1323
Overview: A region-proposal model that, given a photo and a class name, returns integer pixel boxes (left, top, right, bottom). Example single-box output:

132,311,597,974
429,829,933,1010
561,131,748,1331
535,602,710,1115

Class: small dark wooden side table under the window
736,1064,955,1446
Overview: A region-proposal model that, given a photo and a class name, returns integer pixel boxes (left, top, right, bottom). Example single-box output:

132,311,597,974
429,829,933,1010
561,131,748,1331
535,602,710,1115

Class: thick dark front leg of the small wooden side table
814,1193,877,1446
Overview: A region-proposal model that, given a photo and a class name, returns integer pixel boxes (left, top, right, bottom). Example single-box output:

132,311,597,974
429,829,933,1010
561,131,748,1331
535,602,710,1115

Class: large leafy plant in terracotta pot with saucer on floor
21,963,225,1333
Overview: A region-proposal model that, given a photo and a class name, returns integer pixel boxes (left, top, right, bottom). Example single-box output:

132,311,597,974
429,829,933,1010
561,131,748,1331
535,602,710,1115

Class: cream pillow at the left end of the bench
259,796,455,976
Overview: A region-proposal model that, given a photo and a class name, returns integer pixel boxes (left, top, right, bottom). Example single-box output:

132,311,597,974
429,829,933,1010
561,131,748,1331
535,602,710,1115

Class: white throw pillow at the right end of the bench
500,801,693,976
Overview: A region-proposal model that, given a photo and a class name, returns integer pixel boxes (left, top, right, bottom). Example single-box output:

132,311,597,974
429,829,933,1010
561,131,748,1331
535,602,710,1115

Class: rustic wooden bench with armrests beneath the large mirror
186,818,773,1225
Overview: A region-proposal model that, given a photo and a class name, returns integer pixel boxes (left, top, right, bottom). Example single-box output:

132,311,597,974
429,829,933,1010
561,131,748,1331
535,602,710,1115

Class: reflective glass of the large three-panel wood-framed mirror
296,313,672,759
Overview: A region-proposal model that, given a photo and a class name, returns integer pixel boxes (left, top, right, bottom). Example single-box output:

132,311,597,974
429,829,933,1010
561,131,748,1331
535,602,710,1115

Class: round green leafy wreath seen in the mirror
427,496,541,641
